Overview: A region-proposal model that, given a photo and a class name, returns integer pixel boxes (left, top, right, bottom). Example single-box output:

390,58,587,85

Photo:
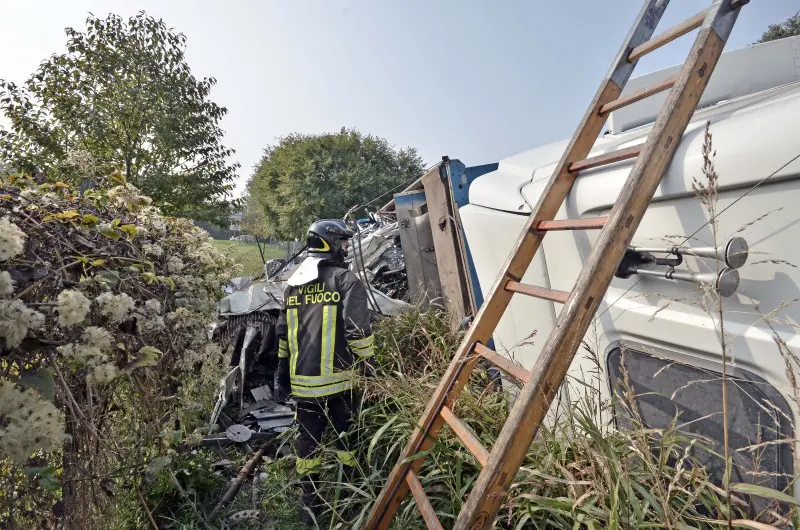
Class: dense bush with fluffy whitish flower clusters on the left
0,173,235,529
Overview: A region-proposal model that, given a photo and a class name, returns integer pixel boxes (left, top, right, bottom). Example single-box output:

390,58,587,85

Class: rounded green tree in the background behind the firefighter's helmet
248,128,423,239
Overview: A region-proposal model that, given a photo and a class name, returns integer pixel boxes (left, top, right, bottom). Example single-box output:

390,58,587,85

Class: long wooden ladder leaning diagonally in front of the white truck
365,0,748,530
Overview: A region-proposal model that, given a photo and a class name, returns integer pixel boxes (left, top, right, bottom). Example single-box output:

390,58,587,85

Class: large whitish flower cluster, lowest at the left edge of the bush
0,379,66,464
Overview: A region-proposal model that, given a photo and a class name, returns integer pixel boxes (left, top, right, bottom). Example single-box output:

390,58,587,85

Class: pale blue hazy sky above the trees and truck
0,0,800,197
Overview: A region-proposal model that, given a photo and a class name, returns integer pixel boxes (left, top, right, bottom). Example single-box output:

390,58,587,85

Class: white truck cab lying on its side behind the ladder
459,37,800,498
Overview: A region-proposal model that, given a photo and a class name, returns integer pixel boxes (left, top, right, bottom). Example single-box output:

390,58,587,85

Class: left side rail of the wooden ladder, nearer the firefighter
364,0,668,530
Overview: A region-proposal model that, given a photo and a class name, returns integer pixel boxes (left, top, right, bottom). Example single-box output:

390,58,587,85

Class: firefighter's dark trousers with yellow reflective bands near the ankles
296,391,355,512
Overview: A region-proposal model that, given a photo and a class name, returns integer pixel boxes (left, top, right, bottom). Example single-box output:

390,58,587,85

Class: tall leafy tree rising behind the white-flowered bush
0,12,239,224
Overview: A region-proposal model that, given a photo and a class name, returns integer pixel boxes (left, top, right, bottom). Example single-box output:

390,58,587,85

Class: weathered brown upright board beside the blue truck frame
422,165,470,327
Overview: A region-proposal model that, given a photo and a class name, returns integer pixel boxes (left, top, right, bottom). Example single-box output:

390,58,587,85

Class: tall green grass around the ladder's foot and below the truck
153,309,786,529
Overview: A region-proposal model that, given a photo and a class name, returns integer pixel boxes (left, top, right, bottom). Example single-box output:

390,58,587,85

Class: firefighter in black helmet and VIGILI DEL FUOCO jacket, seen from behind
275,220,375,523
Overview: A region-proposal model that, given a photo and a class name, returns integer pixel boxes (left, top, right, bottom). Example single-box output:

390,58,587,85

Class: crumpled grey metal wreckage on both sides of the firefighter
204,214,410,448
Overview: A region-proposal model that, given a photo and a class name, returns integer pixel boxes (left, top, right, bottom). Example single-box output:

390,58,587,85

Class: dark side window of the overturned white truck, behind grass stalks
607,347,793,509
